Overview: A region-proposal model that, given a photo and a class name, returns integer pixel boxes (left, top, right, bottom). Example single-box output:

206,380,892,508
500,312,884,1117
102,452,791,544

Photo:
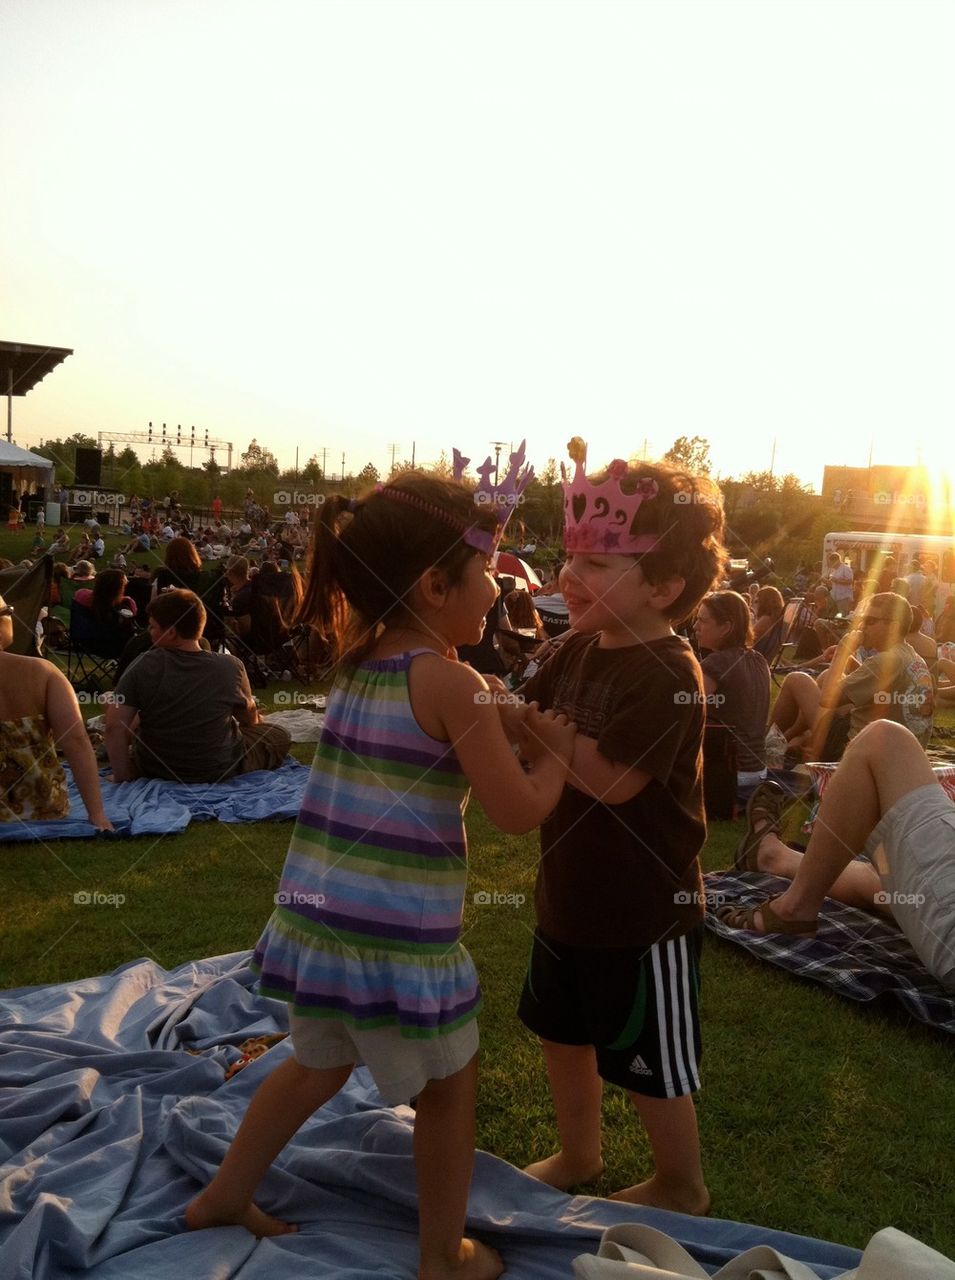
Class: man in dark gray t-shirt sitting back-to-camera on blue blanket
105,590,291,782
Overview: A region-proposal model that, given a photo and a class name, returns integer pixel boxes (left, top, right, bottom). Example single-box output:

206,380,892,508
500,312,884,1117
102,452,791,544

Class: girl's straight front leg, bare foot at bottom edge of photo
415,1055,504,1280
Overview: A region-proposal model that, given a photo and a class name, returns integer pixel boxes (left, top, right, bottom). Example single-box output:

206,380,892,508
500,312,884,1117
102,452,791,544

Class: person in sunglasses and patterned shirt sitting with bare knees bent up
769,591,935,760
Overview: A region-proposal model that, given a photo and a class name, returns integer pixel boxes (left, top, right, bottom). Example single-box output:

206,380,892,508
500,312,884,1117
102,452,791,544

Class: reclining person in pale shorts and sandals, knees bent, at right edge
717,719,955,989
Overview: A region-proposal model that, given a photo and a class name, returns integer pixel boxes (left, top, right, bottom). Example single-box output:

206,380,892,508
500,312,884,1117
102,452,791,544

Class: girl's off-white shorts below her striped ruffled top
282,1012,479,1107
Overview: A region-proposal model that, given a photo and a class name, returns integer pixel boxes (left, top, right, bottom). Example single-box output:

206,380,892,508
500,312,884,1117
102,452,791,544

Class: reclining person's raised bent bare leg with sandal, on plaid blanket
742,721,936,932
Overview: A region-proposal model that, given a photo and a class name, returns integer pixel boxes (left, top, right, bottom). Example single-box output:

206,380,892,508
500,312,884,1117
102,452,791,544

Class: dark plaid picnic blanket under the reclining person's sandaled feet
704,870,955,1034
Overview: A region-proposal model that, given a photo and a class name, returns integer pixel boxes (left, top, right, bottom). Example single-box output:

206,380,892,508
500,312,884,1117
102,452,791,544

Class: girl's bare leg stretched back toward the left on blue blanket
186,1057,352,1235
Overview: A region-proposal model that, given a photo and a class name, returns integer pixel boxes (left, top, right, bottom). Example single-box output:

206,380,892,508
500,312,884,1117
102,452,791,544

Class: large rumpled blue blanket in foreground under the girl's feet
0,952,859,1280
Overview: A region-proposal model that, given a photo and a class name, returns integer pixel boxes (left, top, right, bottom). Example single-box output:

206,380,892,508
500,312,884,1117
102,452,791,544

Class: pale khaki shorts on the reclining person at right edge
864,782,955,988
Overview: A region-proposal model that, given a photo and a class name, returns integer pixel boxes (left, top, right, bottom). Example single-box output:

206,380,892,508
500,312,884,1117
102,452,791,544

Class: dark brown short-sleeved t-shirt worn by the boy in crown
521,635,707,947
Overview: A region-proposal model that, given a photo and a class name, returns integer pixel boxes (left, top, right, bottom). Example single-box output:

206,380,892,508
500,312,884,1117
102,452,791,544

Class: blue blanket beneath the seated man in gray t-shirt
0,755,309,842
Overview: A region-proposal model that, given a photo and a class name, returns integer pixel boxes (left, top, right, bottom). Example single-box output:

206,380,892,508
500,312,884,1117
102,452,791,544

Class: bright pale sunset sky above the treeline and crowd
0,0,955,486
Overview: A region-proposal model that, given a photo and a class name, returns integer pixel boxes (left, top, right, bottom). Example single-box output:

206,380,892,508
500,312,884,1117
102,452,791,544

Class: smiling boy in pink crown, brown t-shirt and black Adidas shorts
518,440,725,1213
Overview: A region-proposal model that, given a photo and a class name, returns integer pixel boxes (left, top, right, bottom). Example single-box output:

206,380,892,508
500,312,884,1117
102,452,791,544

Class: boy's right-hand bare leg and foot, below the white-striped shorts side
611,1093,710,1215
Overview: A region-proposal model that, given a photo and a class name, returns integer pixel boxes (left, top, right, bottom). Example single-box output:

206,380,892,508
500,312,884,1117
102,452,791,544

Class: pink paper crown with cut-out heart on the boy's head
561,435,658,556
